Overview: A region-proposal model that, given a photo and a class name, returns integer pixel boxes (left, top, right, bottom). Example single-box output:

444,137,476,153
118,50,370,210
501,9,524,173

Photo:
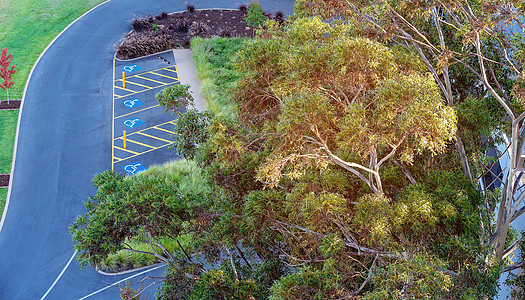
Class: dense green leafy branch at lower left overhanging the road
70,158,206,269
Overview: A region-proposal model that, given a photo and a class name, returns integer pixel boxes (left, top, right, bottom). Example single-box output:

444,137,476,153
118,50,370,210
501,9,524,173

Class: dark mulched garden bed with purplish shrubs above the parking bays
117,9,284,59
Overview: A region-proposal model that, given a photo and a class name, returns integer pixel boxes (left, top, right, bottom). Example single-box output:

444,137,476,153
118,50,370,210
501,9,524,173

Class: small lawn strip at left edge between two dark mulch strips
0,110,18,175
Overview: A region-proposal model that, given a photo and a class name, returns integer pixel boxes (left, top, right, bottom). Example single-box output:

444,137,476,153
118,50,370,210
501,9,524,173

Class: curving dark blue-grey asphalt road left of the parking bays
0,0,293,299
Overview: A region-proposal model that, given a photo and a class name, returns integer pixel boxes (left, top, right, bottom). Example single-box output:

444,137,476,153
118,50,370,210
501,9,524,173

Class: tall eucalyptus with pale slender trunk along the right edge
296,0,525,271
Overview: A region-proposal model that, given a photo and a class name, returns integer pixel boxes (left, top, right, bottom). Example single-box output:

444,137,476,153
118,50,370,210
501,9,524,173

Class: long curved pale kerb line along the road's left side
0,0,111,233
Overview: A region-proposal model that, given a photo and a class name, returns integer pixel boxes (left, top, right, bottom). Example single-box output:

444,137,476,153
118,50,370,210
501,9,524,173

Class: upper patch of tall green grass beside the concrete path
191,37,246,118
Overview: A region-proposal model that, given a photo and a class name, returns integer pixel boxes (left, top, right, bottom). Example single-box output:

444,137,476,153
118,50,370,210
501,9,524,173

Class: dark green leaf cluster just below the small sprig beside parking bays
173,109,212,159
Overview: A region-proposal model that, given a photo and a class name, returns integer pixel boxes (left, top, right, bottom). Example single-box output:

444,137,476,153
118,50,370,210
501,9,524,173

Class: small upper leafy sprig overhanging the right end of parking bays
155,84,193,114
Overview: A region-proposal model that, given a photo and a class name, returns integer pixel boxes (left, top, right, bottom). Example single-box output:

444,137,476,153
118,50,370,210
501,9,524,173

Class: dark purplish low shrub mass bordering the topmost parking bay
117,32,174,59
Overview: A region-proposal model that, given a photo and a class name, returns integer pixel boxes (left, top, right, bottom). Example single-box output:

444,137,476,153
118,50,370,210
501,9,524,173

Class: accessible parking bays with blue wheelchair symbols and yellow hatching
111,51,180,175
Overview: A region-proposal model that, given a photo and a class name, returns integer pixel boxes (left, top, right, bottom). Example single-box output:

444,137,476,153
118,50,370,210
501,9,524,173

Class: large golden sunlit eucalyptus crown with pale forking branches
236,17,456,192
